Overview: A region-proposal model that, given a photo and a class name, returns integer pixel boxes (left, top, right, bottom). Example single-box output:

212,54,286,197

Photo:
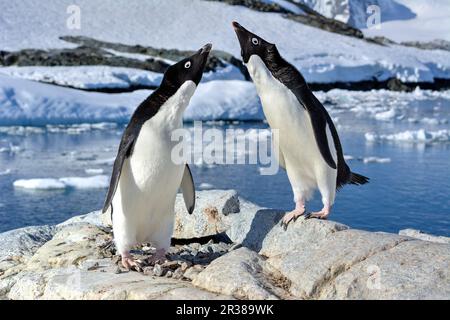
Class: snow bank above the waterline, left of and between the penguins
0,75,264,125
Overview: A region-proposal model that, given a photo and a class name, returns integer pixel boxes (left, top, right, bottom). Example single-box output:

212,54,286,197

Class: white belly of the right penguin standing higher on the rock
259,79,337,198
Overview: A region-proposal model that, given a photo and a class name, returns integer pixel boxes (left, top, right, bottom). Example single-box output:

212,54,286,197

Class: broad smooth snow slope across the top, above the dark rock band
0,0,450,82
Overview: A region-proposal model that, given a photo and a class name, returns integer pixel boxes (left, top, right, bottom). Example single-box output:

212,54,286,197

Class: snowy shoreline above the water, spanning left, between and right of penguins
0,74,450,130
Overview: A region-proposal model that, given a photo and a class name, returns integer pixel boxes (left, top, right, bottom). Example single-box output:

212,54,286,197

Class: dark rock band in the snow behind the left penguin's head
0,36,248,85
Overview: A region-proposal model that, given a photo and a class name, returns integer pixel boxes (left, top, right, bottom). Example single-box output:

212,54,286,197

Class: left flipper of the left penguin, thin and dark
102,132,135,215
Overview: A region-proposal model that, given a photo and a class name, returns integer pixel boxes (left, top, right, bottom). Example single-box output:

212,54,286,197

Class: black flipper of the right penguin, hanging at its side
296,88,337,169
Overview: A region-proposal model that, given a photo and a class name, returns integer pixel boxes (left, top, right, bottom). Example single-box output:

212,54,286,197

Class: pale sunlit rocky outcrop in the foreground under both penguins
0,190,450,299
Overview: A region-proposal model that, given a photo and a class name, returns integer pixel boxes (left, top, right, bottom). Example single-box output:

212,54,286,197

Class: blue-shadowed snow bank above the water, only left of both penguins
0,75,149,126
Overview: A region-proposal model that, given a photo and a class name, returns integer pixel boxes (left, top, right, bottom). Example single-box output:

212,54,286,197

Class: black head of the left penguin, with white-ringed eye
161,43,212,88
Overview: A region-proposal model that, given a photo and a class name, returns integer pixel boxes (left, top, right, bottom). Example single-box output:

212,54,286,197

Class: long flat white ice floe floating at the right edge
365,129,450,143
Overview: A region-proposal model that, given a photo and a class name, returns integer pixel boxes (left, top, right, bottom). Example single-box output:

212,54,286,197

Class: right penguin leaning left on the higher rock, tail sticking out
233,22,369,228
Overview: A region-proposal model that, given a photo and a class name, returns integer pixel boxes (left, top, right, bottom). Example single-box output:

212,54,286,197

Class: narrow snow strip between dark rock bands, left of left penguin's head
0,66,163,89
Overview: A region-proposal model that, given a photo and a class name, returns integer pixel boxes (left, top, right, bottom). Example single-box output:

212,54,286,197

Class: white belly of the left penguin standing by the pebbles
113,121,184,250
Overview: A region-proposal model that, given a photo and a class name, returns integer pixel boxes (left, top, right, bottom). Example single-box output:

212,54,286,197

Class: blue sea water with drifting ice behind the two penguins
0,97,450,236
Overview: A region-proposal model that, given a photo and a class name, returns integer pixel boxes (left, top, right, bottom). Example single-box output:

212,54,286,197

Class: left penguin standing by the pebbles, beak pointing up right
103,44,212,269
